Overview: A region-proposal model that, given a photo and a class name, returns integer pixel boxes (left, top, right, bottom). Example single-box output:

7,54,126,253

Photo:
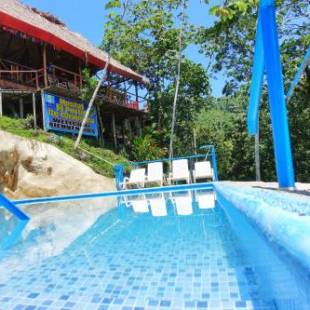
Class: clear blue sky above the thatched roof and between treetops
22,0,224,97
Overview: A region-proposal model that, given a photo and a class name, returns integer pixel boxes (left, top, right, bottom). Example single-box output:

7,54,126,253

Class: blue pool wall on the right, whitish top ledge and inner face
215,184,310,309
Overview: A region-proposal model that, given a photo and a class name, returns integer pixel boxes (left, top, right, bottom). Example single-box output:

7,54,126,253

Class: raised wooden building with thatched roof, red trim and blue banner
0,0,148,149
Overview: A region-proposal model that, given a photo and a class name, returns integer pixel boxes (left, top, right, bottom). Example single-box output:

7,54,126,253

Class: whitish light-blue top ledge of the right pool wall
215,183,310,270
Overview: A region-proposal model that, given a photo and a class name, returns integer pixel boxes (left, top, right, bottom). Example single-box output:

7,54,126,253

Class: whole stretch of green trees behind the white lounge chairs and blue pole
102,0,310,182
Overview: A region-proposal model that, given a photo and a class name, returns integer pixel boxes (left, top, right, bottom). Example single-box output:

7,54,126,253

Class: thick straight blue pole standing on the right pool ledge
259,0,295,188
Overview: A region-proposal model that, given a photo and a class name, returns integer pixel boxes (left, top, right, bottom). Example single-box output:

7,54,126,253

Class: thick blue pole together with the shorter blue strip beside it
248,0,295,188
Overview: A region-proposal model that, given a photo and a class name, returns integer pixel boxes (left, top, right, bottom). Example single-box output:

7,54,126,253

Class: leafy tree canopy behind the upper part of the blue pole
196,0,310,95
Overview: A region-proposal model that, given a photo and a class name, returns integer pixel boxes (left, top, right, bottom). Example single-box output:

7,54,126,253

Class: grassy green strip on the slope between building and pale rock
0,117,127,177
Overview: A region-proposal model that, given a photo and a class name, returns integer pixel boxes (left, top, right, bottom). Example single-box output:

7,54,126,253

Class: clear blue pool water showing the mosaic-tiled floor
0,190,308,310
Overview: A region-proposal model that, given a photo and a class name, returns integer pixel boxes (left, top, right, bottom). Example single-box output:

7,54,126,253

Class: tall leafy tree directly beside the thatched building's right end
102,0,210,154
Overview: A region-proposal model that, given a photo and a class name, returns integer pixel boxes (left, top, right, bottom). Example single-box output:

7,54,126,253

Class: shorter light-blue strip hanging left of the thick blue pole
248,16,264,135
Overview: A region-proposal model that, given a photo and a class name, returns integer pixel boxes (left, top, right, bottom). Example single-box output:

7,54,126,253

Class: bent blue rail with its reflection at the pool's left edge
0,194,30,250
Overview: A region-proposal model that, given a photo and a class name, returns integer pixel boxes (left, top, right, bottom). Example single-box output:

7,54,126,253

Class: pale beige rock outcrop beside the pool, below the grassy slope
0,131,115,199
